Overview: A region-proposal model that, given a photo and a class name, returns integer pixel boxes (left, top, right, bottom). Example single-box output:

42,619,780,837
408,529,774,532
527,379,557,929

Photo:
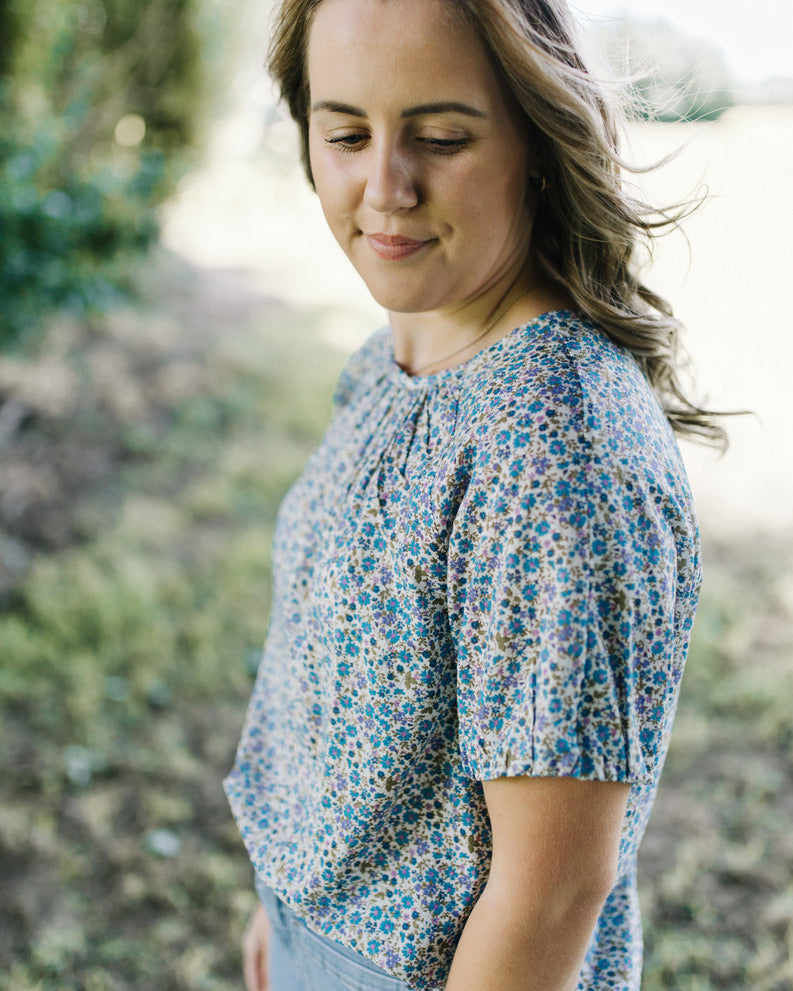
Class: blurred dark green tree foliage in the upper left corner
0,0,207,347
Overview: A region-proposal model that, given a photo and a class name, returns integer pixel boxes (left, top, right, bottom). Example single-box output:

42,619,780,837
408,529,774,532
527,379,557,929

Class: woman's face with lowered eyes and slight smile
308,0,533,313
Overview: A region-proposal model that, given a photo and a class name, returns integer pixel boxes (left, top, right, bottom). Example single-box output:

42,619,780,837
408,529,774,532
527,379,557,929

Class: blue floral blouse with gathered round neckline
225,312,700,991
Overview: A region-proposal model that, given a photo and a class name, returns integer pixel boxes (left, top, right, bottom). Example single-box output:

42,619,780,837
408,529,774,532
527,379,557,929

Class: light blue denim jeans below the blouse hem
256,878,410,991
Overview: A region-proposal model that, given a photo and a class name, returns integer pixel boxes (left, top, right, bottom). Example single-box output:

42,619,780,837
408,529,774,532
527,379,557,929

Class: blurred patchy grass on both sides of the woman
0,257,793,991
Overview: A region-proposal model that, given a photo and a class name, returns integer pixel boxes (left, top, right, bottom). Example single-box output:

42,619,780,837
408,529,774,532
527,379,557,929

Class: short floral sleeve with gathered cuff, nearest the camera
447,378,682,783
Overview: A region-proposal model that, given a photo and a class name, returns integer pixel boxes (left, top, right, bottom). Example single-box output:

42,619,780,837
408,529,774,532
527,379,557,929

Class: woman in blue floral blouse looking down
226,0,722,991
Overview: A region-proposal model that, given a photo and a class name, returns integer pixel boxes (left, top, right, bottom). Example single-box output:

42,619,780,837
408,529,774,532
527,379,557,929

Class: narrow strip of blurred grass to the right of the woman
641,539,793,991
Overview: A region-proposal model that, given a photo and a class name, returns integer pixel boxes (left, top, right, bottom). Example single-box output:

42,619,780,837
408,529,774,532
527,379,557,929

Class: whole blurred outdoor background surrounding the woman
0,0,793,991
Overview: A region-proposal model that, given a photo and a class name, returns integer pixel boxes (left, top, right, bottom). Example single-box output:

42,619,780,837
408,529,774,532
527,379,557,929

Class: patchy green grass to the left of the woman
0,252,342,991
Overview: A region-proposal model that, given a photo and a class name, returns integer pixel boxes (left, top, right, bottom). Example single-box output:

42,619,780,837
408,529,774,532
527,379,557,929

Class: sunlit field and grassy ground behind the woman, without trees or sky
0,101,793,991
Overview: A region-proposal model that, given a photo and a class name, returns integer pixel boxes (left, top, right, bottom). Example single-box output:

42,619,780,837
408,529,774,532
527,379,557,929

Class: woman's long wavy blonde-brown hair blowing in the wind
268,0,727,449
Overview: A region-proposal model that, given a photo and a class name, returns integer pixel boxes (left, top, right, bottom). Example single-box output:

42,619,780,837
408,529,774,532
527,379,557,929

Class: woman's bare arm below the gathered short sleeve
446,777,630,991
